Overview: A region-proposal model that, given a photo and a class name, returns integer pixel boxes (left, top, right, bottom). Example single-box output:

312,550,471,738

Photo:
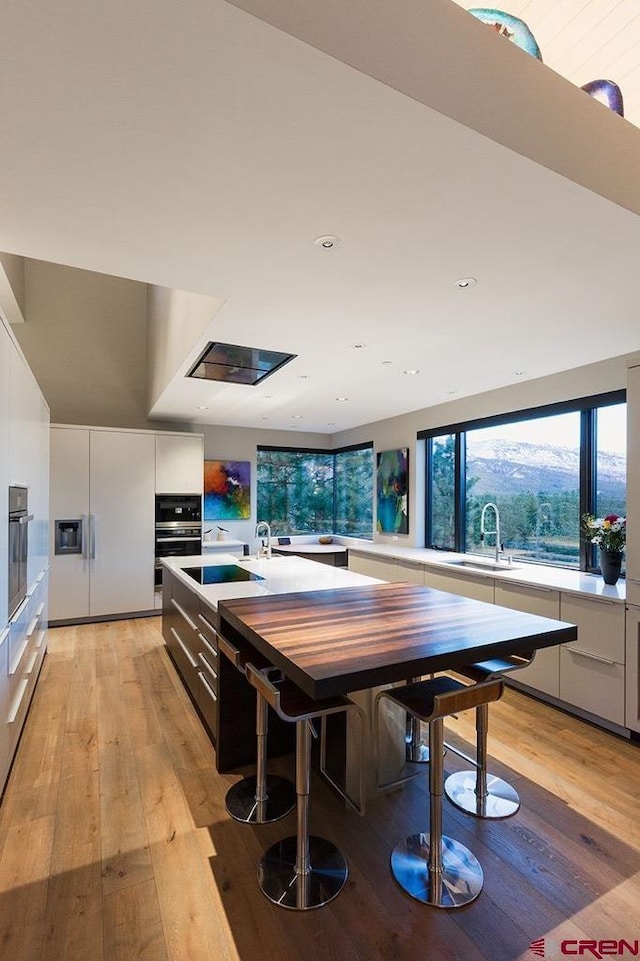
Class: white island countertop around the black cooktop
162,553,380,608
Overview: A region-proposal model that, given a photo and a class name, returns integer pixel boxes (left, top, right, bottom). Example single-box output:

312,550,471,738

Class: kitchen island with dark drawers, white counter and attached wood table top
163,556,577,792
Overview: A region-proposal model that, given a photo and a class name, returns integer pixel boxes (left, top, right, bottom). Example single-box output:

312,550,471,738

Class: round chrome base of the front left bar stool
258,835,349,911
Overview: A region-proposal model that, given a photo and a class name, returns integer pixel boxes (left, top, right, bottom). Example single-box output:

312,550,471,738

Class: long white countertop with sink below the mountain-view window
349,543,626,604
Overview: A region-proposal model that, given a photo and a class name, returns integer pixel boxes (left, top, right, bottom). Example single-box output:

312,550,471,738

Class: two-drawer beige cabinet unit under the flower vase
560,593,625,726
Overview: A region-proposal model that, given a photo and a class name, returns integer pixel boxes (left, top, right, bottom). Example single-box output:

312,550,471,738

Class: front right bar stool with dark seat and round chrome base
376,676,504,908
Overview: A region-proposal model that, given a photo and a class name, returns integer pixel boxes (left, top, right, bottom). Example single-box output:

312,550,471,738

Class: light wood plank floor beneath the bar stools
0,618,640,961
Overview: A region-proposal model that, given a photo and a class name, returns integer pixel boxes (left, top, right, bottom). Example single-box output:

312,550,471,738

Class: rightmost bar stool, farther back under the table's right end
444,651,535,819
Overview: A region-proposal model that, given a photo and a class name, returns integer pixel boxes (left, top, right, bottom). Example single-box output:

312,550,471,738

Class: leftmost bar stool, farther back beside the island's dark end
218,634,296,824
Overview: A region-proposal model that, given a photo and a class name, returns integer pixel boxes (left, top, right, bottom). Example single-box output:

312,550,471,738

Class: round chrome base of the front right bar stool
391,834,483,908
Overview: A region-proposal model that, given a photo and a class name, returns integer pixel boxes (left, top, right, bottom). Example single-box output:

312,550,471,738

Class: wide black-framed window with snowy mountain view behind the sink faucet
418,391,626,570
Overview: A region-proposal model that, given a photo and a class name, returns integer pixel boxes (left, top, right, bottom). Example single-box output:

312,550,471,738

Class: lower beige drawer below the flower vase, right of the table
560,644,624,725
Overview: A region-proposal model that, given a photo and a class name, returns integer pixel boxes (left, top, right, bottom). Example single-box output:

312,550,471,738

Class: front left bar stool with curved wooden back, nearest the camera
246,662,364,911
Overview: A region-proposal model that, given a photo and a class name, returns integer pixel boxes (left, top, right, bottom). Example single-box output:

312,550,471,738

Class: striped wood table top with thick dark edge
218,583,578,699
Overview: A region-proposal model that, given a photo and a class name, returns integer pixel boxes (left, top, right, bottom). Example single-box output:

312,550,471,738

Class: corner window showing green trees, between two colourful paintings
257,445,373,537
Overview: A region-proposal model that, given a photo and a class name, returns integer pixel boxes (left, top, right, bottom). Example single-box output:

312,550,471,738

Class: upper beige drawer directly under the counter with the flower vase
560,594,625,664
